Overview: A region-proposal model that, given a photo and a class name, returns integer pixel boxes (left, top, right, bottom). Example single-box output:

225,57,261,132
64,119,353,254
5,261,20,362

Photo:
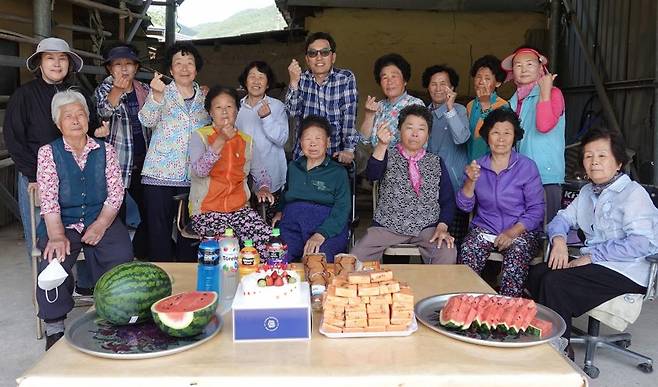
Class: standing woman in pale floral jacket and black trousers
139,43,210,261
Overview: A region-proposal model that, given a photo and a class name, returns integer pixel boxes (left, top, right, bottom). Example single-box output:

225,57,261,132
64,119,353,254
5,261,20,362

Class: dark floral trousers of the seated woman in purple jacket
459,226,541,297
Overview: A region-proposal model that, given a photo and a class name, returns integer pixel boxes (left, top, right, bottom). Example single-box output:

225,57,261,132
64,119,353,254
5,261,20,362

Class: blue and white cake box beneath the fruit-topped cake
232,282,311,342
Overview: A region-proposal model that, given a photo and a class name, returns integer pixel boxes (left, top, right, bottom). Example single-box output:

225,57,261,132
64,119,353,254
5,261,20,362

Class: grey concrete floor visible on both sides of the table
0,215,658,387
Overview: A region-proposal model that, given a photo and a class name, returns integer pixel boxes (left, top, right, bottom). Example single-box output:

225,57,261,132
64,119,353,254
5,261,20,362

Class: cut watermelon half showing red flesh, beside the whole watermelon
151,291,218,337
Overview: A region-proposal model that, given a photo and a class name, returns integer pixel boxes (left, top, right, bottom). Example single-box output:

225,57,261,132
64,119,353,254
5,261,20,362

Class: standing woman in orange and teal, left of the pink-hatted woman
466,55,507,160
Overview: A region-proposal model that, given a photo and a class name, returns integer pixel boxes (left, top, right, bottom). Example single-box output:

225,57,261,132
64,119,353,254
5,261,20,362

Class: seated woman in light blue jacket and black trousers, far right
528,127,658,349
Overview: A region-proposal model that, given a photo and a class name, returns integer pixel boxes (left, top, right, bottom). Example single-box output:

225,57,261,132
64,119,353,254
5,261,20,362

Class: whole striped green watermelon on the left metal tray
94,261,171,325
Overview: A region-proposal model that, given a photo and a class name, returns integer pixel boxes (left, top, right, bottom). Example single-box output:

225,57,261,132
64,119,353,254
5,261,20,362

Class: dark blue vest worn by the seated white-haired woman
38,138,107,236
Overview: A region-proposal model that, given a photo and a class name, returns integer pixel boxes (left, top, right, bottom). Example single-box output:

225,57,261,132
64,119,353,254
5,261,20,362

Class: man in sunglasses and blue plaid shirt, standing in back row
286,32,359,164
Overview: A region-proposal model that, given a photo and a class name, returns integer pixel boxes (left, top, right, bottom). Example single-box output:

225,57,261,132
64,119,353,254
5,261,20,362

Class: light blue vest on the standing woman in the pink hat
509,85,565,184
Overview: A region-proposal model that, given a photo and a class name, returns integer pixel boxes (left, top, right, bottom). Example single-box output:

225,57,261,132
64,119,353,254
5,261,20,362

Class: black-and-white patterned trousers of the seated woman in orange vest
192,207,272,259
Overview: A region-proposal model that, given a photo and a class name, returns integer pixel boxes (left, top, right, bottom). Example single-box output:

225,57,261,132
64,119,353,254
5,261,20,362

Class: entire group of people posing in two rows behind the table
4,32,658,358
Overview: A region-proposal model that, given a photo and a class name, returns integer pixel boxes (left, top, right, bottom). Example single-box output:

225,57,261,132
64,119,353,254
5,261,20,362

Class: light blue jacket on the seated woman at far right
548,175,658,286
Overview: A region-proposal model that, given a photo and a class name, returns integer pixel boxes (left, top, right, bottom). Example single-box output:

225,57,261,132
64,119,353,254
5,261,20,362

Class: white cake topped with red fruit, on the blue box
240,266,301,303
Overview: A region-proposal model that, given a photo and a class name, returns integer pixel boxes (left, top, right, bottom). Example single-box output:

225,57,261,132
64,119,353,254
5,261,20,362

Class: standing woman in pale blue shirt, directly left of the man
236,61,288,222
